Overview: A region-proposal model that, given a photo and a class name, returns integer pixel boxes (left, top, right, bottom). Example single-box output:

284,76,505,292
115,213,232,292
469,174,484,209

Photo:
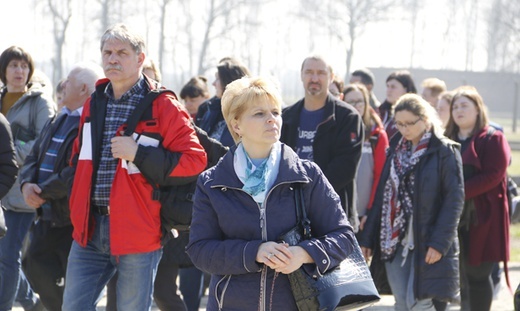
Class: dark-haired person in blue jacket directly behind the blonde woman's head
195,57,250,147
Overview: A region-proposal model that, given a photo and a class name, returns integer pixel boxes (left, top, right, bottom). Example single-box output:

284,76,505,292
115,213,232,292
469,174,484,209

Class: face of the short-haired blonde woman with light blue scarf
232,100,282,150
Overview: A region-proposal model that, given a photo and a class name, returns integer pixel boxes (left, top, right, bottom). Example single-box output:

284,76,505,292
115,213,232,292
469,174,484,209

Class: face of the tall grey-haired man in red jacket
101,39,144,84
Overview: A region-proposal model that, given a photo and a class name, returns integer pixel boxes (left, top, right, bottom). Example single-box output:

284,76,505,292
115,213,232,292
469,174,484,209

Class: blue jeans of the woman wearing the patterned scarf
385,245,435,311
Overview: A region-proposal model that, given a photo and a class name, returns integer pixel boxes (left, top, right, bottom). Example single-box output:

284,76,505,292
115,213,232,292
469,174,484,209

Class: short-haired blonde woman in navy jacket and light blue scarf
187,78,354,311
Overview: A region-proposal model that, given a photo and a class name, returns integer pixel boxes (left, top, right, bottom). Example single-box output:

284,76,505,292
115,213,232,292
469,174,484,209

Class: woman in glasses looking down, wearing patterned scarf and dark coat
359,94,464,310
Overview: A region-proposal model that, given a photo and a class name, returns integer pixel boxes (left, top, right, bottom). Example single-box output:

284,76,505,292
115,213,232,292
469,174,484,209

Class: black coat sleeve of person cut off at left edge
0,113,18,199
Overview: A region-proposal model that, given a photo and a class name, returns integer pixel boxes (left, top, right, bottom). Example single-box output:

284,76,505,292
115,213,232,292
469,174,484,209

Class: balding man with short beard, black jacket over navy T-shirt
280,56,364,231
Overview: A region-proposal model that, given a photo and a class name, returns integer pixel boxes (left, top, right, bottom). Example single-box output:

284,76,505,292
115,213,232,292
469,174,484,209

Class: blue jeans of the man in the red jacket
62,215,162,311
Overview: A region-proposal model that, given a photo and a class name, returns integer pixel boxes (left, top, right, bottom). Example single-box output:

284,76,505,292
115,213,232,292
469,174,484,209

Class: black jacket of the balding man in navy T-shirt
280,94,365,231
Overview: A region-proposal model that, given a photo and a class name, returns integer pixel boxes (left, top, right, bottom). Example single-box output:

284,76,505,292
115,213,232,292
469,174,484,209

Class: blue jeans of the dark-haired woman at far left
0,211,37,311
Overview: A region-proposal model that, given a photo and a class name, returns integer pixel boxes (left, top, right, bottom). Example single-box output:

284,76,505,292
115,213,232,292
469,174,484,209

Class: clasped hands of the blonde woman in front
256,242,312,274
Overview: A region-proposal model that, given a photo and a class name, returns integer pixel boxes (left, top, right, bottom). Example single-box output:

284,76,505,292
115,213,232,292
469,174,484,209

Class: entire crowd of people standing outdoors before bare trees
0,24,511,311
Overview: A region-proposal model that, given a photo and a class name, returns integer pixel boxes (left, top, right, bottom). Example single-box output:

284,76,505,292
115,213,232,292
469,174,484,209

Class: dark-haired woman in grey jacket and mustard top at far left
0,46,56,310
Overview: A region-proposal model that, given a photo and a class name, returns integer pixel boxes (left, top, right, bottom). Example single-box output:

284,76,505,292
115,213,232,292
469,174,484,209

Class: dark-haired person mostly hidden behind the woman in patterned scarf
379,70,417,139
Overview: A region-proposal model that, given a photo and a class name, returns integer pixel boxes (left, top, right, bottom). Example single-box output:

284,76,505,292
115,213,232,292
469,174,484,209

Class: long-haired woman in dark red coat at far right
446,86,510,311
